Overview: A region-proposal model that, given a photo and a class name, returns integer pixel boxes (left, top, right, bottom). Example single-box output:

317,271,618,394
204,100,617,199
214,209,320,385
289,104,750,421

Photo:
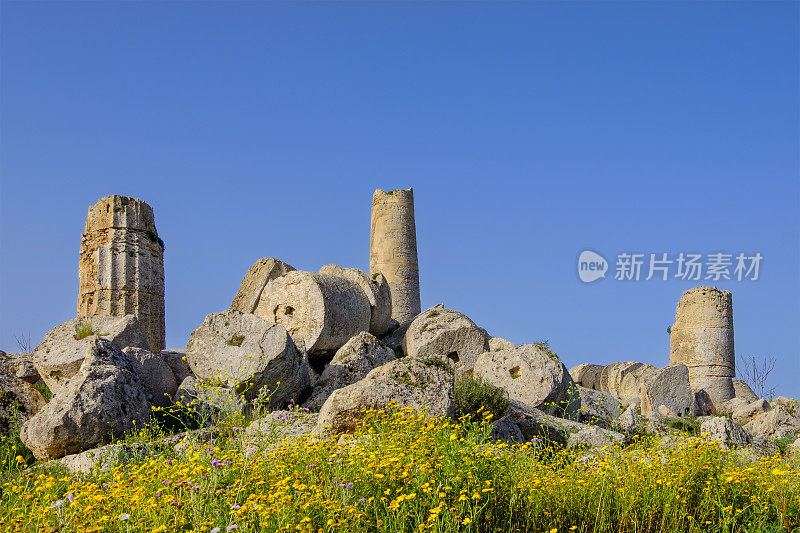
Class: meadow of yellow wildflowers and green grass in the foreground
0,409,800,533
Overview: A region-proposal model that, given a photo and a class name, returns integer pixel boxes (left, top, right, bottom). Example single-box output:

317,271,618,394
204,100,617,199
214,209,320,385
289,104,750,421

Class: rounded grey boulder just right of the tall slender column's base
403,304,489,373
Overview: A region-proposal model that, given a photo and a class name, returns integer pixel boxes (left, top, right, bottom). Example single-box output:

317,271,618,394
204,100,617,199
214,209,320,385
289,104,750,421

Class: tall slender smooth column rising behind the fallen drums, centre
369,189,421,324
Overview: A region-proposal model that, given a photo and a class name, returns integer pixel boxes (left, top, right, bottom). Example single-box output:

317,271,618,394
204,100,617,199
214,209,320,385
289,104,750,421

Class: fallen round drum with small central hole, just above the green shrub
473,344,581,417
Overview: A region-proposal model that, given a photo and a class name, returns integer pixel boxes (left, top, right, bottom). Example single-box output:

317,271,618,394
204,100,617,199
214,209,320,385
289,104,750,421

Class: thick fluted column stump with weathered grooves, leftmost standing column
78,194,164,353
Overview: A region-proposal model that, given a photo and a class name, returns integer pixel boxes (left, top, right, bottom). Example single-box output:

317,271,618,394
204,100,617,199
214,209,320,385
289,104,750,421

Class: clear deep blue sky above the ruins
0,1,800,397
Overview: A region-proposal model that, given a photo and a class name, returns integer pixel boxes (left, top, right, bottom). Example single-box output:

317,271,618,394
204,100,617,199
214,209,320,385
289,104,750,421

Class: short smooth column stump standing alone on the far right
669,287,736,407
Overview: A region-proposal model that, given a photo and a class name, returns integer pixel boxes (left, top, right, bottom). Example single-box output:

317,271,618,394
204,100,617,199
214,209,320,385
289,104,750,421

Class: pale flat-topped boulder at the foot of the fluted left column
33,315,150,396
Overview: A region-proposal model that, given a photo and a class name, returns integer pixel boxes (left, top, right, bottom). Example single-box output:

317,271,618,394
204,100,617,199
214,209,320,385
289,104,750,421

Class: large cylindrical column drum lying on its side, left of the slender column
256,270,372,355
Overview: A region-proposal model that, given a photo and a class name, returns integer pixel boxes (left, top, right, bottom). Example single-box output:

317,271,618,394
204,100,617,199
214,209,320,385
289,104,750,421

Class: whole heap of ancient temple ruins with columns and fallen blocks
0,189,800,468
